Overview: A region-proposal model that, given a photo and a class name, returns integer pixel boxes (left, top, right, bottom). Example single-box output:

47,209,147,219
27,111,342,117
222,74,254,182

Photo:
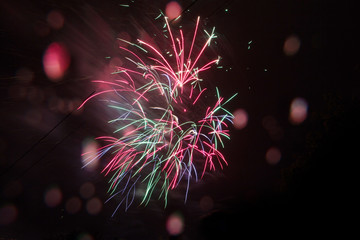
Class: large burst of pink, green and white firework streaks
79,18,236,213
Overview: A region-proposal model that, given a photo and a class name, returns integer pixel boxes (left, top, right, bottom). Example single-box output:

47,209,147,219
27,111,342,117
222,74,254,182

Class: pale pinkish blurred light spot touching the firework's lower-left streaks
81,139,99,171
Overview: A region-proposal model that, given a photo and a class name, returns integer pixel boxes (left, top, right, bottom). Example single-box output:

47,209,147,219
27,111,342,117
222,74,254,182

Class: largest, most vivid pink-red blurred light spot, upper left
43,42,70,82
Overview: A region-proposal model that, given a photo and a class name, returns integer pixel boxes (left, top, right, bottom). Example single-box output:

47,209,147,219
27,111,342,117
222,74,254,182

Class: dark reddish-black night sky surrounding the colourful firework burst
0,0,360,240
